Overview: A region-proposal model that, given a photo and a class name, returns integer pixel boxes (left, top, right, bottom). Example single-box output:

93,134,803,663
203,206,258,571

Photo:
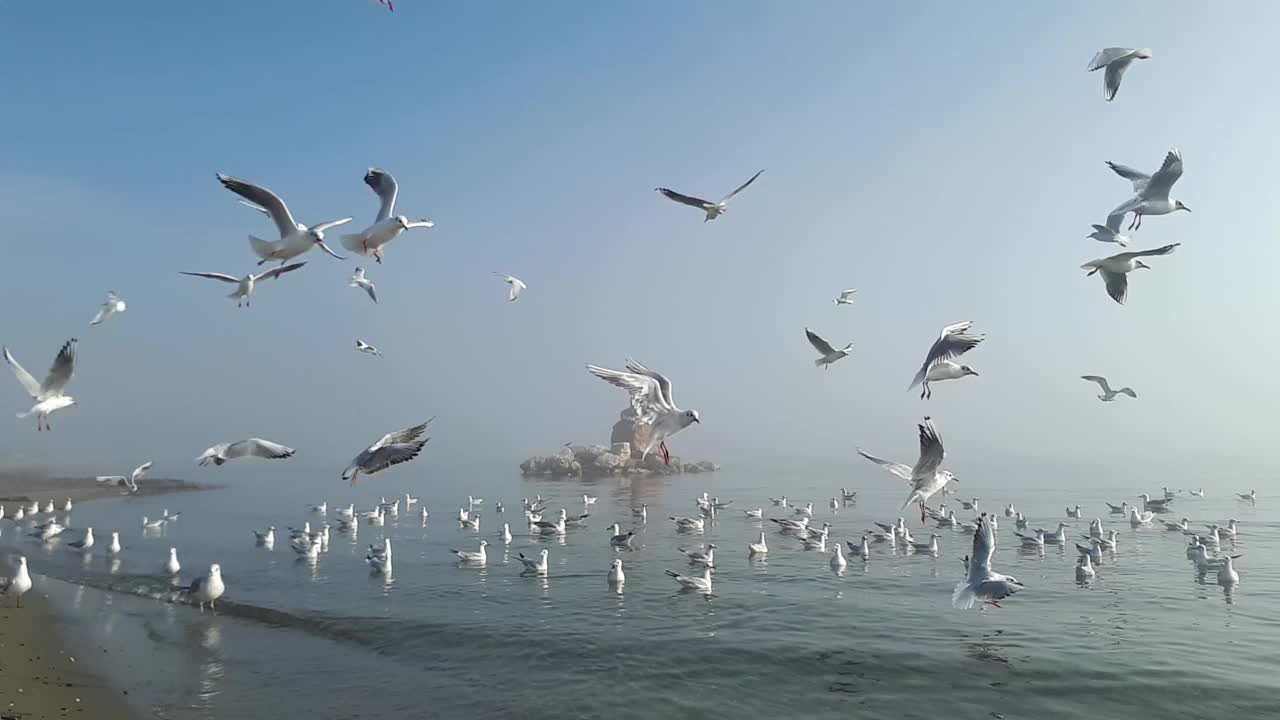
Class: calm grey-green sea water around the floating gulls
0,462,1280,720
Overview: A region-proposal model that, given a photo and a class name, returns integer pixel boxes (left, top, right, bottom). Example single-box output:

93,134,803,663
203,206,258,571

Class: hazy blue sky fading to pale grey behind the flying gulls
0,0,1280,483
